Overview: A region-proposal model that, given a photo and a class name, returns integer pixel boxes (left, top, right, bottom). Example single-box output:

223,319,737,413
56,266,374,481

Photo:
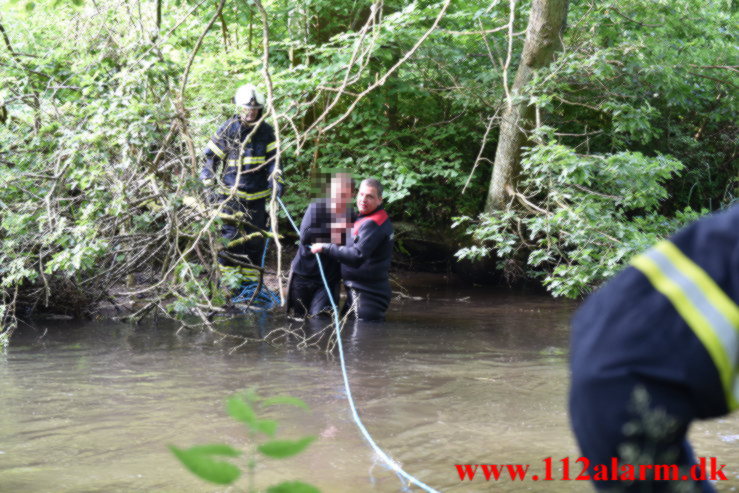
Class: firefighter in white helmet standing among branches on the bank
200,84,283,296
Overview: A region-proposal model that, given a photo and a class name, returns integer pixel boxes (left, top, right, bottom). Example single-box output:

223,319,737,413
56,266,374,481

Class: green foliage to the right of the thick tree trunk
458,1,739,297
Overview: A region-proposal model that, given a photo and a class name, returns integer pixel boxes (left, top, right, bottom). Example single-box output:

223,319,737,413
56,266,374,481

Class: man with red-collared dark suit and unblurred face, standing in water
311,178,393,321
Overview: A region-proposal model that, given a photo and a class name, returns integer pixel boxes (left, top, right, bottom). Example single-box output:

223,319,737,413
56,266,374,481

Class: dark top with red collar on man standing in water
324,206,393,291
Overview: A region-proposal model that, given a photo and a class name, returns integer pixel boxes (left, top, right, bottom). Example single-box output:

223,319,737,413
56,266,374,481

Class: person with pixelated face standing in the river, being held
287,173,353,318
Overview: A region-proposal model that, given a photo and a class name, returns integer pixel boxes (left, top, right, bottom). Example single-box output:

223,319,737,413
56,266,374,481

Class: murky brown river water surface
0,276,739,493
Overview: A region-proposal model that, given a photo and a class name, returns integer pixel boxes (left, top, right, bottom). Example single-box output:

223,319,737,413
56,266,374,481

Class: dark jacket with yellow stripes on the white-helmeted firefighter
200,115,282,200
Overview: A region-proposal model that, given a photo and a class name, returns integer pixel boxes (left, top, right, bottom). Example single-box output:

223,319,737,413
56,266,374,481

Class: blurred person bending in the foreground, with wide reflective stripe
570,205,739,492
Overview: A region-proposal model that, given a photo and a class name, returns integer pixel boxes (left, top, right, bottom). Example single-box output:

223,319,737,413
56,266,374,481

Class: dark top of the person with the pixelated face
292,199,351,285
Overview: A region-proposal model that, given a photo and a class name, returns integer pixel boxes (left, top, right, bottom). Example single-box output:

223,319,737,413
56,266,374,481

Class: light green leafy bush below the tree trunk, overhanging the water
456,142,708,298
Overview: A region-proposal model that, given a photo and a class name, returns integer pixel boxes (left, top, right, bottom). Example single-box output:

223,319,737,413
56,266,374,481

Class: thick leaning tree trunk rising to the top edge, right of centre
485,0,568,212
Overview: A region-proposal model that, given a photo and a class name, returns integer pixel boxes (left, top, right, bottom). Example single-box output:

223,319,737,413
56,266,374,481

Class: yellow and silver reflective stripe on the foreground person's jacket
631,241,739,410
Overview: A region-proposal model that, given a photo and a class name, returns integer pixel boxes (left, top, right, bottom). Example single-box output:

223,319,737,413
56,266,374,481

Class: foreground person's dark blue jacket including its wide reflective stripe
571,205,739,418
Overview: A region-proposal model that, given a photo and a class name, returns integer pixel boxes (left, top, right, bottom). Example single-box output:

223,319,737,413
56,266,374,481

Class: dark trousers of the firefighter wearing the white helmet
218,196,267,267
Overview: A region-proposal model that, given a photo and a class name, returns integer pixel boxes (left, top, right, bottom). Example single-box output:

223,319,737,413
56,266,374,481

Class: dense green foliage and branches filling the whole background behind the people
0,0,739,338
